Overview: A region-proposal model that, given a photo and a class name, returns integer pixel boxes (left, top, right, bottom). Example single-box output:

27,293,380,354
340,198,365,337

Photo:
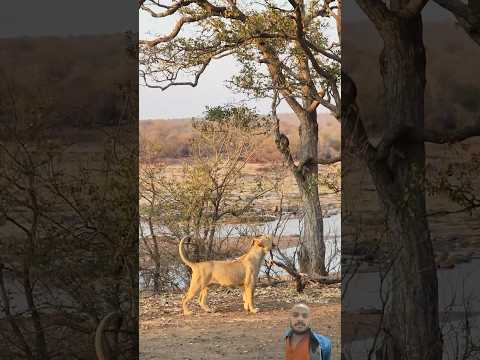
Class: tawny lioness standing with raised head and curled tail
178,235,272,315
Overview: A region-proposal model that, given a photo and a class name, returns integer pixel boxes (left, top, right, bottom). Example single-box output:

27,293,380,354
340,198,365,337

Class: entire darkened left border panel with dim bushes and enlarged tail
0,0,138,360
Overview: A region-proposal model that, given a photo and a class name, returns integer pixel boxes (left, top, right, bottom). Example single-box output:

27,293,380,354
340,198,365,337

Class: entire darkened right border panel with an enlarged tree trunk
342,0,480,360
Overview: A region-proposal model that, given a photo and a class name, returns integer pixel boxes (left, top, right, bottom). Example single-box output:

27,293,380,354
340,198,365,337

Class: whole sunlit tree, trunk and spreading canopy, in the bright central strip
140,0,341,274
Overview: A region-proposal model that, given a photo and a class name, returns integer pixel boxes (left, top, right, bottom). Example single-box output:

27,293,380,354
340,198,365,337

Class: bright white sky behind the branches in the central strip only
139,7,335,120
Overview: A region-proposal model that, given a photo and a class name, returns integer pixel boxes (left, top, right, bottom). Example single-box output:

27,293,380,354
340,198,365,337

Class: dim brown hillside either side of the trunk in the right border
342,21,480,133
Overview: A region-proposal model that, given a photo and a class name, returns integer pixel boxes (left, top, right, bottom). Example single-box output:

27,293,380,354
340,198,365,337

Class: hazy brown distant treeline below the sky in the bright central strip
139,114,340,163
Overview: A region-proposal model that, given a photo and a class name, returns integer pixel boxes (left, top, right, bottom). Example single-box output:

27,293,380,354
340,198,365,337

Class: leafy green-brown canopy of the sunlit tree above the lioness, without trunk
140,0,340,111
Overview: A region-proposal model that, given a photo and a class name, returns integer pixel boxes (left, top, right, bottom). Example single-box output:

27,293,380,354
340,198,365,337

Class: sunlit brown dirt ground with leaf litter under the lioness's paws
140,283,341,360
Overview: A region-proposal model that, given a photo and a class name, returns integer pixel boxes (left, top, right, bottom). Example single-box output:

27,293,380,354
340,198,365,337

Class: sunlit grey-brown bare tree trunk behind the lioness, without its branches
295,111,326,275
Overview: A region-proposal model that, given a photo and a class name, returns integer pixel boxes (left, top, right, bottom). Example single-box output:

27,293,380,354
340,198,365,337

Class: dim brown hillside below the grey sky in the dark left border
0,34,138,132
